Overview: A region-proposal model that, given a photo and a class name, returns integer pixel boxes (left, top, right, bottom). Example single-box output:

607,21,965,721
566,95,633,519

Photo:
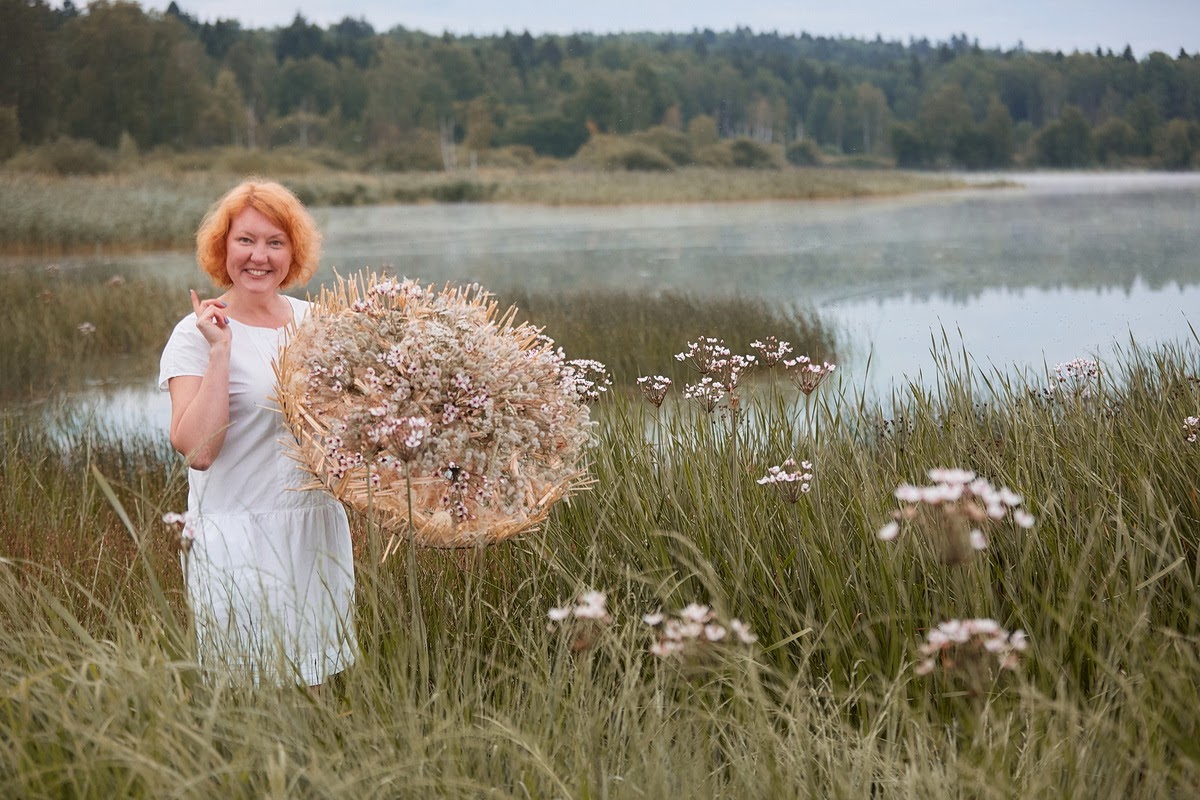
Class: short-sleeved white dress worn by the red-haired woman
158,297,356,685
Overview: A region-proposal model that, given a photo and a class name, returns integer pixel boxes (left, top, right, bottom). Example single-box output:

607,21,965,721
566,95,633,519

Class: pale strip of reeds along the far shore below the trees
0,162,959,255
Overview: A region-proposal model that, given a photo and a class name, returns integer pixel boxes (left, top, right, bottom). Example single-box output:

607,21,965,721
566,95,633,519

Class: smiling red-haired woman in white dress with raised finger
158,179,355,686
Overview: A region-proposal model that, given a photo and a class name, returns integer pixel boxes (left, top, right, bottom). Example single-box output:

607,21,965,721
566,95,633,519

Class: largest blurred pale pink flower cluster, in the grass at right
878,469,1034,564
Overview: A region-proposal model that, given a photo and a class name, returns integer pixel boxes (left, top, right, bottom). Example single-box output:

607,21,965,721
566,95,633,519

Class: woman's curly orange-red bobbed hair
196,178,320,289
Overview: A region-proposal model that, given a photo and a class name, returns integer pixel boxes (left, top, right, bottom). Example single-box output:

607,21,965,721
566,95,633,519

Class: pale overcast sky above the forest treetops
136,0,1200,56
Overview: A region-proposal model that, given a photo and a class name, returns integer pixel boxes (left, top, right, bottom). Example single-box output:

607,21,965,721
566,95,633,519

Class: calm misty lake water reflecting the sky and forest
25,174,1200,438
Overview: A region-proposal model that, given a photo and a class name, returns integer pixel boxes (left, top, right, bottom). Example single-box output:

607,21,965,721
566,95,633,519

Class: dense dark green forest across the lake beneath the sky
0,0,1200,169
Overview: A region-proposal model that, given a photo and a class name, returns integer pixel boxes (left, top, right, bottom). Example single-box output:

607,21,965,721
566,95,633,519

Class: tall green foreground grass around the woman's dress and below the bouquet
0,338,1200,798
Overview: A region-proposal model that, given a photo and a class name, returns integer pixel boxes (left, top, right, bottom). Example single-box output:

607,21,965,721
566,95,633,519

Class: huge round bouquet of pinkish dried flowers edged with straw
276,272,602,557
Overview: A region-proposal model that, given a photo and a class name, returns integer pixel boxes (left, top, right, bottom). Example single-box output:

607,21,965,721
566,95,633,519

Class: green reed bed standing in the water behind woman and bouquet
0,269,835,401
